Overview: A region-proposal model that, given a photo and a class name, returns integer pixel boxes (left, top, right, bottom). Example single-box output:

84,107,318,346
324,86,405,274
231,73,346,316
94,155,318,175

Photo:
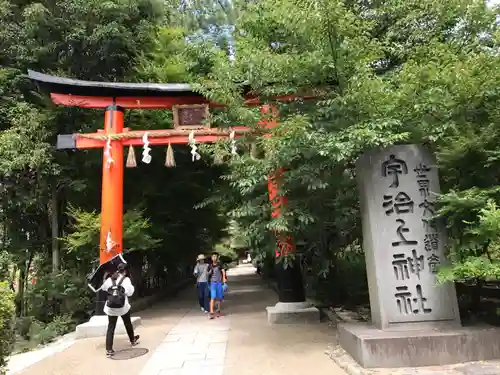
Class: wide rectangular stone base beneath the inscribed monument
338,323,500,368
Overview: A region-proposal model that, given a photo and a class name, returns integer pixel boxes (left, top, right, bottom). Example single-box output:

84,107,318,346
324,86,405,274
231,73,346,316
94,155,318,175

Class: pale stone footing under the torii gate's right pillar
266,302,319,324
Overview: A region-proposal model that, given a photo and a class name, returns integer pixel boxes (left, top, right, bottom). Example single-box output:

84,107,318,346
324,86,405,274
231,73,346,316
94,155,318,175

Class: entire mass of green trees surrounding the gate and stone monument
0,0,500,342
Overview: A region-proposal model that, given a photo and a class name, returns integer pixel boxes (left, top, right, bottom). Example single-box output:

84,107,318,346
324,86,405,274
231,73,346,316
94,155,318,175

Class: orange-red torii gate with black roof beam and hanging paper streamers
28,70,312,324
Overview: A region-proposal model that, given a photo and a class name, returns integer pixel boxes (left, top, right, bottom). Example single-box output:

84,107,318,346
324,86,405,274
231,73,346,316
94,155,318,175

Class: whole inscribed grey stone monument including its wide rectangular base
339,145,500,367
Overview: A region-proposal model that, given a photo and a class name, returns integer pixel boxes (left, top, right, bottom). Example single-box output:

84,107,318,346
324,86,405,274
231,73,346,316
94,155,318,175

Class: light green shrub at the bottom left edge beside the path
0,282,15,375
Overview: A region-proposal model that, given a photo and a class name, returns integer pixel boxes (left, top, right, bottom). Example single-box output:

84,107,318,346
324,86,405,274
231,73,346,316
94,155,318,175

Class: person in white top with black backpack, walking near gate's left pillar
100,263,139,357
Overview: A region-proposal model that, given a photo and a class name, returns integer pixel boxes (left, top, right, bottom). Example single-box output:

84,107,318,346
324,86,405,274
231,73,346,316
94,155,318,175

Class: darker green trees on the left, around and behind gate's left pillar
0,0,229,347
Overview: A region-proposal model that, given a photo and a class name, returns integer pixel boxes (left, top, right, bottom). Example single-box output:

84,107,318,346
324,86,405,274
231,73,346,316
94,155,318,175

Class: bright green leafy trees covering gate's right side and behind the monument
189,0,500,306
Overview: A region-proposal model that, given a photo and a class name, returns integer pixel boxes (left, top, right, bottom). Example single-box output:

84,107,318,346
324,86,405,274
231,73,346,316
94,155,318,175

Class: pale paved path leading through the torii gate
12,265,345,375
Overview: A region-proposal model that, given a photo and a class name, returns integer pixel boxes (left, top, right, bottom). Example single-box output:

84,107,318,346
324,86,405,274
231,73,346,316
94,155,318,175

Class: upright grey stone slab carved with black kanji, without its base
356,145,458,329
